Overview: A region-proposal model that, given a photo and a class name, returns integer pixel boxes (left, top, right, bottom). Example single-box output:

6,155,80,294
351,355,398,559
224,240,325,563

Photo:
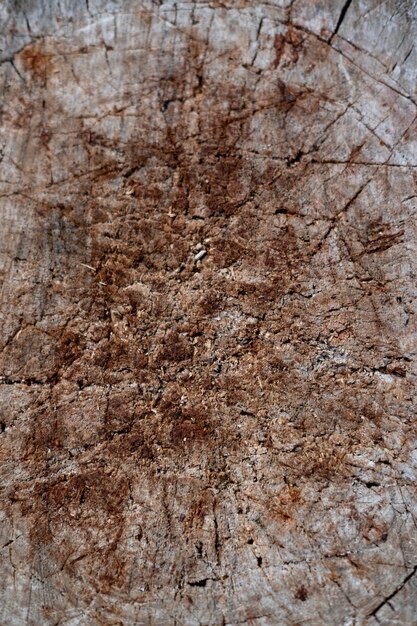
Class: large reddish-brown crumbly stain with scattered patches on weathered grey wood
3,14,410,615
